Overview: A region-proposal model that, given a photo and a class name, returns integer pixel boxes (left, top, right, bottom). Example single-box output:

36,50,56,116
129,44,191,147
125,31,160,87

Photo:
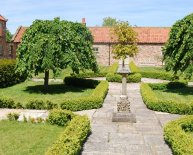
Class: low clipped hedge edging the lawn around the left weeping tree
0,77,109,111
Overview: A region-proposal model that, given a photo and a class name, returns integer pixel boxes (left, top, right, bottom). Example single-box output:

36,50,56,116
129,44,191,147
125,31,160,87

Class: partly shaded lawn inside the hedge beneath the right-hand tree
154,87,193,103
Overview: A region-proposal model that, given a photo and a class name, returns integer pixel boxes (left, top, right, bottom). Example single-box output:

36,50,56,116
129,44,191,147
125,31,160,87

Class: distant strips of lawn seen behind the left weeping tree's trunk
34,66,110,79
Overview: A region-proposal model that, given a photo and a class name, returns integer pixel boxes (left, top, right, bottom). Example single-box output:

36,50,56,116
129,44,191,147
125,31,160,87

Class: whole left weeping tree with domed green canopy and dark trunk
16,18,98,90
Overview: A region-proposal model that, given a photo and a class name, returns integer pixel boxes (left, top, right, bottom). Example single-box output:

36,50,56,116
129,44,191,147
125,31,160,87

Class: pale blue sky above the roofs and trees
0,0,193,33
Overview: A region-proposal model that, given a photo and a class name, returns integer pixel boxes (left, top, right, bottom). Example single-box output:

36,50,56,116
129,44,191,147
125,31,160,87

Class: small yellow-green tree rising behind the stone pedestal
111,21,138,66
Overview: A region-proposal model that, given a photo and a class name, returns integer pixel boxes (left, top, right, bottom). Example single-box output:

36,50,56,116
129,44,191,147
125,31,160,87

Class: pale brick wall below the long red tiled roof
93,44,163,66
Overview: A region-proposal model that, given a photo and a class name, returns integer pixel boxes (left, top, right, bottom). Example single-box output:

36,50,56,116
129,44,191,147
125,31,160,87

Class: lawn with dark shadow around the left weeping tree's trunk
0,81,94,105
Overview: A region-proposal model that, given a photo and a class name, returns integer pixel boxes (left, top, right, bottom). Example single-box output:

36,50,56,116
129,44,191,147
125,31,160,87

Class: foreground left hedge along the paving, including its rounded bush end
45,110,91,155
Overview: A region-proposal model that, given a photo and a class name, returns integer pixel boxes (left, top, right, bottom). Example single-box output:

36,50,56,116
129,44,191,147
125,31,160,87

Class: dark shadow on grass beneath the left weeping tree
24,84,87,94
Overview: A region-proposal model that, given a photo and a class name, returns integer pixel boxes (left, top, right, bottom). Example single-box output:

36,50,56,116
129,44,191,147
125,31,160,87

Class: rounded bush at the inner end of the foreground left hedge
47,109,75,126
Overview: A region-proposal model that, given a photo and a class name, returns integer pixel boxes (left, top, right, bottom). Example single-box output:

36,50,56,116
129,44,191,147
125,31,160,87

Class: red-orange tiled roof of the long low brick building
13,27,170,43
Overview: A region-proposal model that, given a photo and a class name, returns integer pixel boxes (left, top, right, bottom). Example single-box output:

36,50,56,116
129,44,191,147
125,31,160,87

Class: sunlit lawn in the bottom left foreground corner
0,121,64,155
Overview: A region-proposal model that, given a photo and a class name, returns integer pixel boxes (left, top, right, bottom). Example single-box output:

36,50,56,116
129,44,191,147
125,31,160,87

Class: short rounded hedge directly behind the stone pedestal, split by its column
106,63,141,83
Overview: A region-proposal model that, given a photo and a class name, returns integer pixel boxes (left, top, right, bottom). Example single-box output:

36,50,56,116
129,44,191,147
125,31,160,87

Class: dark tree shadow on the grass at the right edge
163,87,193,96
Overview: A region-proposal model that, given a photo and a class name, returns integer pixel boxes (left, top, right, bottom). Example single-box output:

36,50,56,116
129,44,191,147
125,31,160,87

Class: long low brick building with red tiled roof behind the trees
13,19,170,66
